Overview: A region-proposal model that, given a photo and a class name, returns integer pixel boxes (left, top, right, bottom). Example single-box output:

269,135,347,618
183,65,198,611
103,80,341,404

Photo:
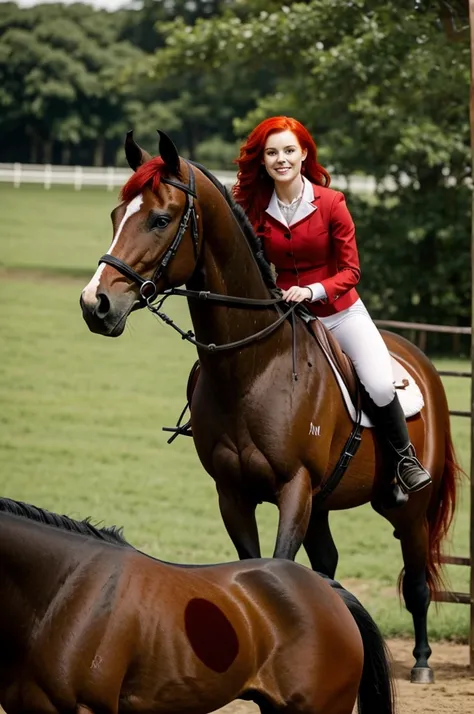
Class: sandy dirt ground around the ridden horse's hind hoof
219,639,474,714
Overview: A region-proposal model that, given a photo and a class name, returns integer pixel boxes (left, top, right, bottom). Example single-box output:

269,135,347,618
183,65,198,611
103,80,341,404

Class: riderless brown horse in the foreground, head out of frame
0,499,394,714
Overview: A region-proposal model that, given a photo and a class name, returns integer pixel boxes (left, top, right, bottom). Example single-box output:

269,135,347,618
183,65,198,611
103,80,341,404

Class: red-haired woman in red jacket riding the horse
233,116,431,505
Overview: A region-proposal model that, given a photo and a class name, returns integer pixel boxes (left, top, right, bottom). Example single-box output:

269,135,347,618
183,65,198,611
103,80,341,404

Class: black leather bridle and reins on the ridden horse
99,162,299,381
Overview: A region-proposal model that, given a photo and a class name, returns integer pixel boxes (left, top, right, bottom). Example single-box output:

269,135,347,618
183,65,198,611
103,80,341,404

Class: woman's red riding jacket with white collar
258,180,360,317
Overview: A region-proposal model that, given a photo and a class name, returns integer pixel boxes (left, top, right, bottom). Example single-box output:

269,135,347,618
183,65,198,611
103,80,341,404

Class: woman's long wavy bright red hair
232,116,331,227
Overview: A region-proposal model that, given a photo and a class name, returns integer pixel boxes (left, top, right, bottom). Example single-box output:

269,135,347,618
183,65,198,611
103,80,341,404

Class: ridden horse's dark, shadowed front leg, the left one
217,487,261,560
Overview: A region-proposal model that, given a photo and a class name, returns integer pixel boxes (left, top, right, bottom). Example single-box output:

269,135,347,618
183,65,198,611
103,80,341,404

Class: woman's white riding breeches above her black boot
320,299,395,407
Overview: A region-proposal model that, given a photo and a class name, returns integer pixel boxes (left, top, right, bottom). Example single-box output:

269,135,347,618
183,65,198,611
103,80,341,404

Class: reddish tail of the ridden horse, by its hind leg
426,422,464,595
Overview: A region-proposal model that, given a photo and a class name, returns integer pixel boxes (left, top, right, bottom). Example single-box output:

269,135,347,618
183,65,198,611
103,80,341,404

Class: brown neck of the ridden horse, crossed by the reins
188,196,278,358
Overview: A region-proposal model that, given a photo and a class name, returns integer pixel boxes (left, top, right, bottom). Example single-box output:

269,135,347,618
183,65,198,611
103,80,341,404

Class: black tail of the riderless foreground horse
333,582,395,714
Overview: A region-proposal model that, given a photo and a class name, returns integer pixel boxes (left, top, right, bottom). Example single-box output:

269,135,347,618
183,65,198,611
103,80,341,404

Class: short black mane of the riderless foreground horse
0,498,132,547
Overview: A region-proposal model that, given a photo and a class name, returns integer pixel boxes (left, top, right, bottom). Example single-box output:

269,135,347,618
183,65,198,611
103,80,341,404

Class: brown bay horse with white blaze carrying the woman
81,132,458,682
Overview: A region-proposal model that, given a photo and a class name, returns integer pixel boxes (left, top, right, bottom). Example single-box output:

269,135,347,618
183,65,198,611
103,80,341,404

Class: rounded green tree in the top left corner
0,4,142,161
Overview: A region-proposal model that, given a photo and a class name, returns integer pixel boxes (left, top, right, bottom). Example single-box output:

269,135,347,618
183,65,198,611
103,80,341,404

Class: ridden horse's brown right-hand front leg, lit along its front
273,466,312,560
